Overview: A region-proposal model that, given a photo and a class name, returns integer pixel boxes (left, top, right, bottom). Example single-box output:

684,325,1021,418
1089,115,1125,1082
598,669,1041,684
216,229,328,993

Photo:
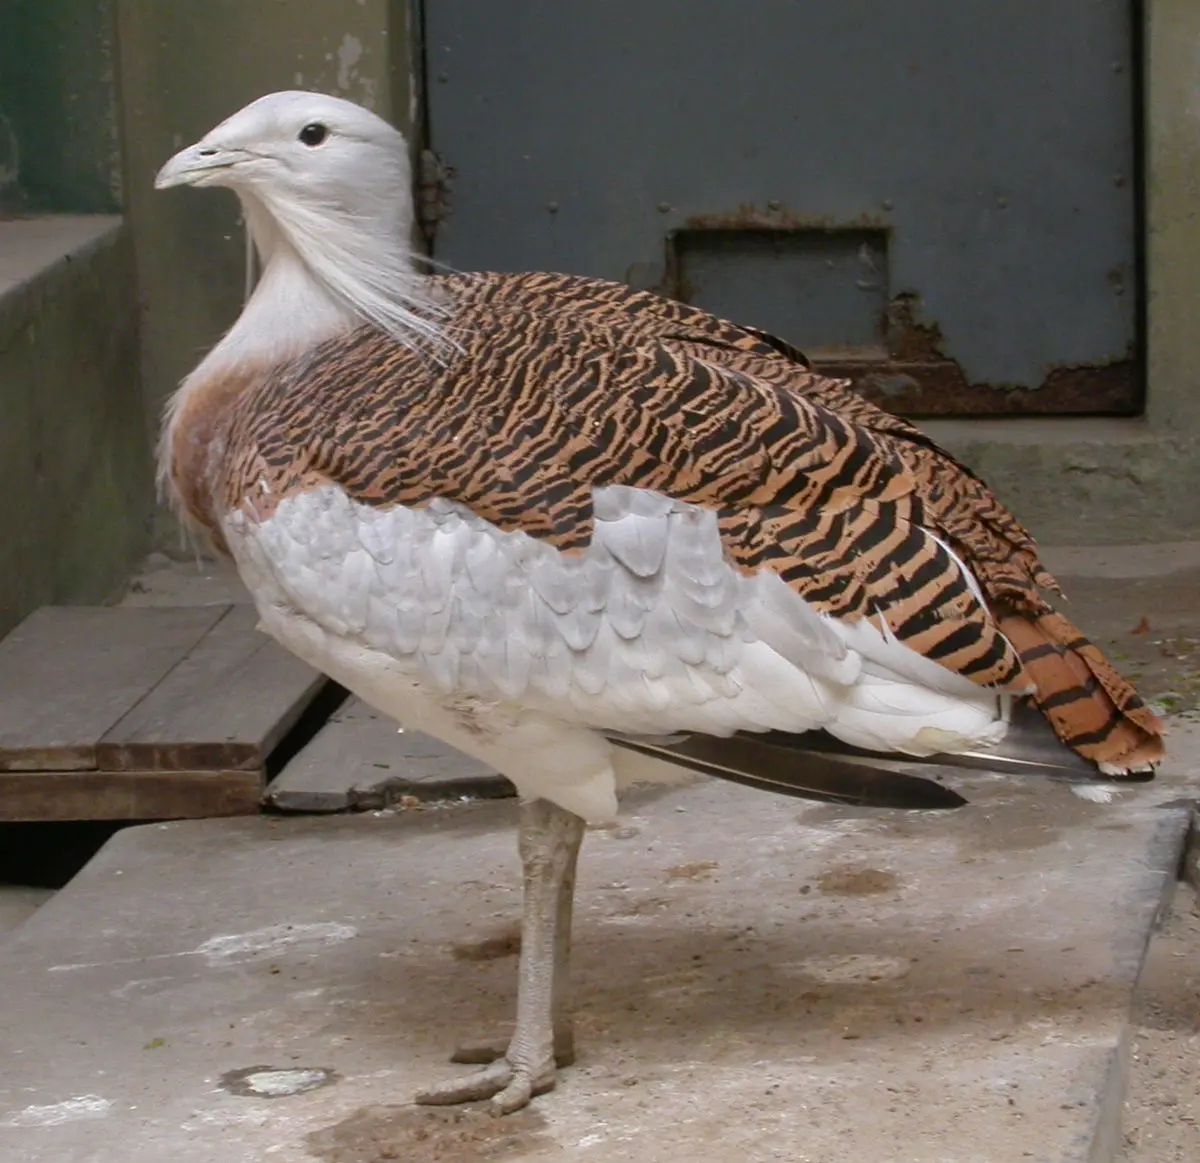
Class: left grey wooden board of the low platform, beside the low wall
0,605,229,772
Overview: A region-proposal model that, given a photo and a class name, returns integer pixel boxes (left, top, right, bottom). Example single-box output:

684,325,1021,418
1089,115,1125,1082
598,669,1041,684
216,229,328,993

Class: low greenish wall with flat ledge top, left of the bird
0,217,152,635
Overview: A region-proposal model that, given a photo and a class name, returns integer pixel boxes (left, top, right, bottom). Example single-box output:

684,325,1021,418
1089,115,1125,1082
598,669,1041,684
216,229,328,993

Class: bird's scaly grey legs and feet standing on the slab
416,799,583,1115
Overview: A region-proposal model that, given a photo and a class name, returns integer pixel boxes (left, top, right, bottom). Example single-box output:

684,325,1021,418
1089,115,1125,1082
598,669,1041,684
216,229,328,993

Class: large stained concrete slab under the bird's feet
0,727,1200,1163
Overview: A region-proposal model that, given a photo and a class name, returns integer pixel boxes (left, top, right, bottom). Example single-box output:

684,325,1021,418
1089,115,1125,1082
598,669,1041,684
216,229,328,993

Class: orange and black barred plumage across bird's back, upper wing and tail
194,274,1162,767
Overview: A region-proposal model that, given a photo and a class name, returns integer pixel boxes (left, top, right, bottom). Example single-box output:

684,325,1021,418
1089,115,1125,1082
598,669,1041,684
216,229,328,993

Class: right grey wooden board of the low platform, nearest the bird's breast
96,606,328,772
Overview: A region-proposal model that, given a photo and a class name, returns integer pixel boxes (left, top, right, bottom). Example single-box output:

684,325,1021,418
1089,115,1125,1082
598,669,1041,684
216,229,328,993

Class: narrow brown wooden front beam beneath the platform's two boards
0,772,264,822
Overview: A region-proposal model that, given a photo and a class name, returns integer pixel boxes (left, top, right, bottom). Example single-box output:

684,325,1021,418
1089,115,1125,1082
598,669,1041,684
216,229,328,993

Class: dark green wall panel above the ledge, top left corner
0,0,120,214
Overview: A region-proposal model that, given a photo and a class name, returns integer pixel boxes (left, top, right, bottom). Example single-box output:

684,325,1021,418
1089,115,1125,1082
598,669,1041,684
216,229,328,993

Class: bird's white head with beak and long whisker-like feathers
155,92,440,346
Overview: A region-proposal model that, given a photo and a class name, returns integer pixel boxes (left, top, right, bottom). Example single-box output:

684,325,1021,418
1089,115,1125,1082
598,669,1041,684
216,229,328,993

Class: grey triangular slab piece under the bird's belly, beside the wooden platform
266,699,512,811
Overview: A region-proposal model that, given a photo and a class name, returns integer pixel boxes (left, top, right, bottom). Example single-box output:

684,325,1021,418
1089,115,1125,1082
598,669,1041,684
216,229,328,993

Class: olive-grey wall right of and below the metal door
926,0,1200,545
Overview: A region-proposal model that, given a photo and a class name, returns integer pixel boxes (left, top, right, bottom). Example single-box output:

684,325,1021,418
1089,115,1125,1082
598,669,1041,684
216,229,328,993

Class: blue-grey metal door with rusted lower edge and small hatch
424,0,1140,415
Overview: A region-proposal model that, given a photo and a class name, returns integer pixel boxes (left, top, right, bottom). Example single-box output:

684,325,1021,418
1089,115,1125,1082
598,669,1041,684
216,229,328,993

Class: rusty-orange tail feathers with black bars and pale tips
1000,613,1166,775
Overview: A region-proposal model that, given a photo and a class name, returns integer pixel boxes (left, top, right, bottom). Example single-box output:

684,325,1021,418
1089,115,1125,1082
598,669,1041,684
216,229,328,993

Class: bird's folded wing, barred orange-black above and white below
214,267,1028,768
